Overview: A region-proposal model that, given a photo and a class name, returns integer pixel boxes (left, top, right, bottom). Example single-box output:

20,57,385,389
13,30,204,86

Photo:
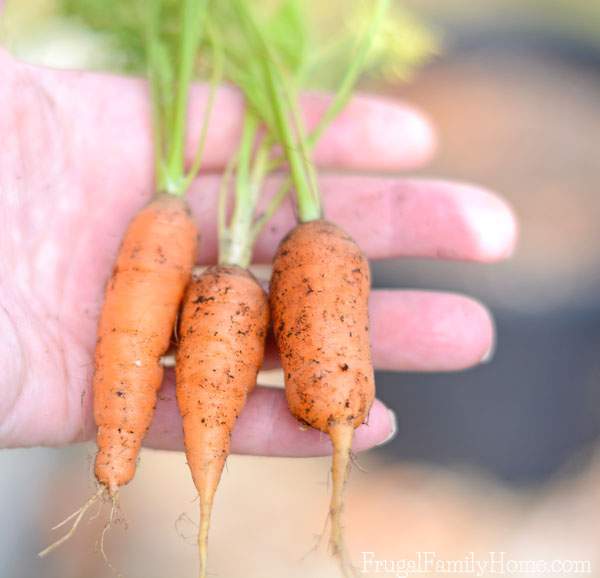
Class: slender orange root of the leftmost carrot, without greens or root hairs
93,195,197,496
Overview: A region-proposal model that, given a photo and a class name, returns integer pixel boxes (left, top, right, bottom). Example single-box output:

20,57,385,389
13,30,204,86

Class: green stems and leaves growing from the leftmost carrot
58,0,220,196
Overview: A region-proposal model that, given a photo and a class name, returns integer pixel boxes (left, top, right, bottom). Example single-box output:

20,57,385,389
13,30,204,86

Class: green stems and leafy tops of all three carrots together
9,0,436,252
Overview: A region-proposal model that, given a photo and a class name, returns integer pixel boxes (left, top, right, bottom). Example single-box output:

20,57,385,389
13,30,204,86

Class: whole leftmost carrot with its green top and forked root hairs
40,0,221,565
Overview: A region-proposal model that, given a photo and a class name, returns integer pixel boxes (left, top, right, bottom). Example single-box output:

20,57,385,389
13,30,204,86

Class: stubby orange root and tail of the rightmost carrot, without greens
270,220,375,571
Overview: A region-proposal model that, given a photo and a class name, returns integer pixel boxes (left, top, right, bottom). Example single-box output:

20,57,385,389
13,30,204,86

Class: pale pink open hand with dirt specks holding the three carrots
0,52,516,455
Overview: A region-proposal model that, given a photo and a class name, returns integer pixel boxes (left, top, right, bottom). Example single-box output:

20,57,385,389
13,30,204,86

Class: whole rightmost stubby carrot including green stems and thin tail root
219,0,389,575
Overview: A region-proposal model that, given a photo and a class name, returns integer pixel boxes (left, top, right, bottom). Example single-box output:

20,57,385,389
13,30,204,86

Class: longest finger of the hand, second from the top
189,175,516,263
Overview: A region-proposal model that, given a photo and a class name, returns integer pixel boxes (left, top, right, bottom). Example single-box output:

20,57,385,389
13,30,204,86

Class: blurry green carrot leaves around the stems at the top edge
50,0,438,90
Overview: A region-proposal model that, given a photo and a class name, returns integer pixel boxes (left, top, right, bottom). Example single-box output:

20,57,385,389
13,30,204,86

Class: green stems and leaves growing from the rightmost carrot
213,0,400,225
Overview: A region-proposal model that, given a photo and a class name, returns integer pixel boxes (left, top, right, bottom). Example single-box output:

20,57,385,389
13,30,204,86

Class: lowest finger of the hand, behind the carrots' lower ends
144,382,395,457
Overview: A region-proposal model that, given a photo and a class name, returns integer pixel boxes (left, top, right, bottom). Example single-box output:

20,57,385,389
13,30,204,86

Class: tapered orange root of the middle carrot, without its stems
176,265,269,577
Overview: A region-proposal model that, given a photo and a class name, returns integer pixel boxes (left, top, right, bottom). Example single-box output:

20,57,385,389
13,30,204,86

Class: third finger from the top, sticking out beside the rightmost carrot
265,290,494,371
